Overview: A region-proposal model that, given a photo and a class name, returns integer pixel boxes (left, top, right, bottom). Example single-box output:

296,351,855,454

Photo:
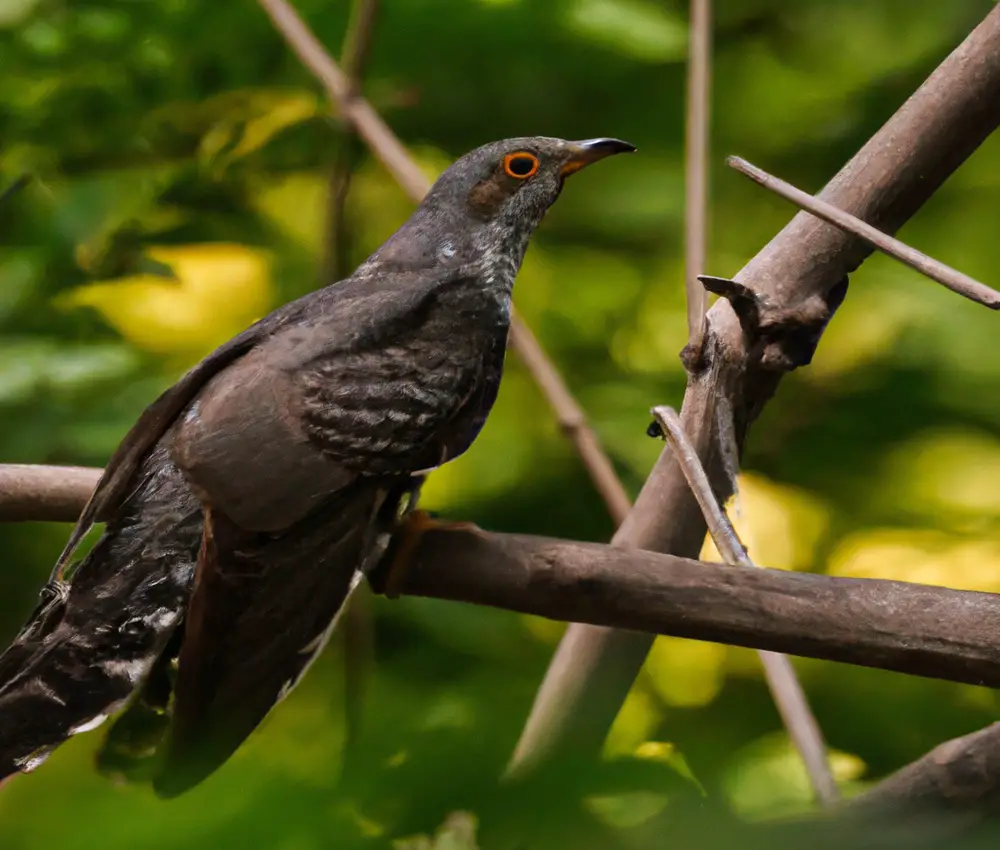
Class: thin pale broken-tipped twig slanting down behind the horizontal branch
652,406,840,806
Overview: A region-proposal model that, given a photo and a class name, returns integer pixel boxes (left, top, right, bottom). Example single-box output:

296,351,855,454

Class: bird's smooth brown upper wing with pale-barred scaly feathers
167,274,481,533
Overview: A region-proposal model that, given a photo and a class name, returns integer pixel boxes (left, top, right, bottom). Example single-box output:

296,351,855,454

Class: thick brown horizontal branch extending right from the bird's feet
373,531,1000,687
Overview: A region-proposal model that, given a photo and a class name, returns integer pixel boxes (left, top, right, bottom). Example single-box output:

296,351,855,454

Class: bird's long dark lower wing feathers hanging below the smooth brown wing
153,482,383,797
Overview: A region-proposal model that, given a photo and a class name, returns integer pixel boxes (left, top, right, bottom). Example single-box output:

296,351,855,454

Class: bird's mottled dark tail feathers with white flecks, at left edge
0,456,201,779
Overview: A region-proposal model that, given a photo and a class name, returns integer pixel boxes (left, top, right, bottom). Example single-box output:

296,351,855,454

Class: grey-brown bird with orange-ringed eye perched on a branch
0,137,634,797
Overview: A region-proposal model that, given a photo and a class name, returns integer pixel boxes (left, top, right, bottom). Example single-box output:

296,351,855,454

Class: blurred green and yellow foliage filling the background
0,0,1000,850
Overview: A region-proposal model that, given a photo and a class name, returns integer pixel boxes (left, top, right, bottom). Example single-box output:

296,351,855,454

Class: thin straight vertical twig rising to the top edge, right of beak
684,0,712,358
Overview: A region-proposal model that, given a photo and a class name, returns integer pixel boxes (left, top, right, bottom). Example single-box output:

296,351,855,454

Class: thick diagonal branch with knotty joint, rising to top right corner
517,0,1000,762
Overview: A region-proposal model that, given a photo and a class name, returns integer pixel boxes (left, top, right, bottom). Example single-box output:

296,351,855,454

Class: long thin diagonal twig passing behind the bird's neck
258,0,630,522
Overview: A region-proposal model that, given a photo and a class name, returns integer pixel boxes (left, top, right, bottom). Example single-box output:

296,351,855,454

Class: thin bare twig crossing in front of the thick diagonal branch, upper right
726,156,1000,310
